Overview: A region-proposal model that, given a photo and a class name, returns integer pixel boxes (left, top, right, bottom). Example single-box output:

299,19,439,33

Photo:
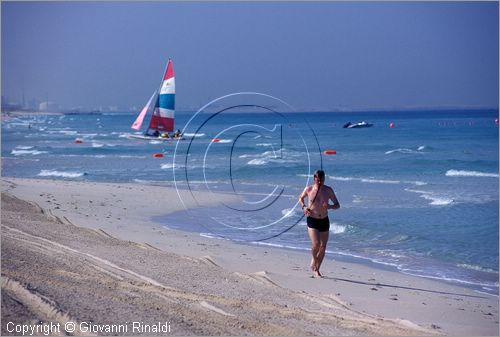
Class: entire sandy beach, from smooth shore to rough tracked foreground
1,177,499,336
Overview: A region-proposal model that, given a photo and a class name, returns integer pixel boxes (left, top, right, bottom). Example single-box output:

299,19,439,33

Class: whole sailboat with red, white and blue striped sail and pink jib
129,59,181,140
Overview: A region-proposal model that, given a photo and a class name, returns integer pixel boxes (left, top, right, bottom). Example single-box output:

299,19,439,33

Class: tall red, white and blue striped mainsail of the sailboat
149,60,175,132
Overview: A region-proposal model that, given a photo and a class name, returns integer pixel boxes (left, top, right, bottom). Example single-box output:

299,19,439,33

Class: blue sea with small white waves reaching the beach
2,109,499,294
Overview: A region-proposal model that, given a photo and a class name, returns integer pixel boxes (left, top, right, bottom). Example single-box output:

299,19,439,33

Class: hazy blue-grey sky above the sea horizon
1,1,499,109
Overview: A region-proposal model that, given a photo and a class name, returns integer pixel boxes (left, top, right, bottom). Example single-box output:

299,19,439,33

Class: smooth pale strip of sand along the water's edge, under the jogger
2,177,498,335
